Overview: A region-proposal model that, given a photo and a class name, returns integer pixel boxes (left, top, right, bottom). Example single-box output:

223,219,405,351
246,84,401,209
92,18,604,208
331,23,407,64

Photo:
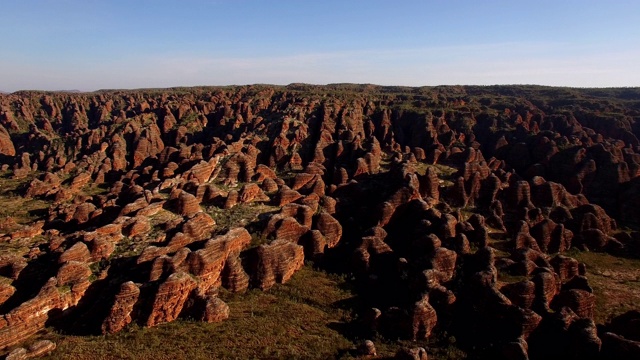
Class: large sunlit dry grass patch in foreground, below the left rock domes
43,267,354,359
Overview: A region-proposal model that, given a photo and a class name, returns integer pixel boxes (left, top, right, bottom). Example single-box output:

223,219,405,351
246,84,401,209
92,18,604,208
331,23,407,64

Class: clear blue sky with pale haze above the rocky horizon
0,0,640,91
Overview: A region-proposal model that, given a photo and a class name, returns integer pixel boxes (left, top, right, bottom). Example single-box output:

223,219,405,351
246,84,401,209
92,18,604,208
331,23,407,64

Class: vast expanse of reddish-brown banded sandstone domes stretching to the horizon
0,84,640,359
